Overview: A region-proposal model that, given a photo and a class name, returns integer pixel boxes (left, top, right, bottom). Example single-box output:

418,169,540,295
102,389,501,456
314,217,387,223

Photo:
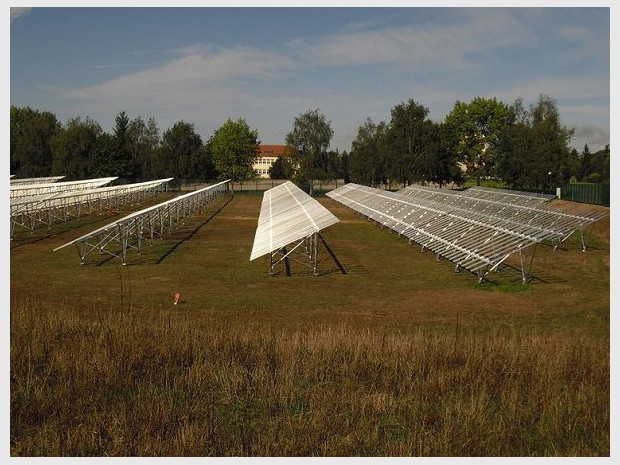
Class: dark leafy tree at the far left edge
10,105,61,177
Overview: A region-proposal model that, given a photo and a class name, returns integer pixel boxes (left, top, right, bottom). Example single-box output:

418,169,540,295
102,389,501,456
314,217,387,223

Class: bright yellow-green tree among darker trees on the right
444,97,514,185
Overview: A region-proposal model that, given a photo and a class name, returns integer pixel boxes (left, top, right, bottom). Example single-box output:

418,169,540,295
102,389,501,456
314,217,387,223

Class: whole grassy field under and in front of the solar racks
10,193,610,456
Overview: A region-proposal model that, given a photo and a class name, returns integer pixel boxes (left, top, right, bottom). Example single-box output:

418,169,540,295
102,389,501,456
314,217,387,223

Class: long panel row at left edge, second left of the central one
11,178,173,238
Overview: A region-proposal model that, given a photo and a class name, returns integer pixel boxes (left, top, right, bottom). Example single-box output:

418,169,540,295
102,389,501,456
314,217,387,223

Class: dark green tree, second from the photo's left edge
51,117,103,179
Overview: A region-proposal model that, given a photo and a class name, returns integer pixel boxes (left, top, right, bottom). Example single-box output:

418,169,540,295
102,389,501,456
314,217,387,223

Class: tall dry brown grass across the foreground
11,306,609,456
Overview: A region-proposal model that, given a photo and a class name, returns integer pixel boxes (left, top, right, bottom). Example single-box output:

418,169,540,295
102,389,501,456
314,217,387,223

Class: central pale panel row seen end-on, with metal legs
250,181,344,274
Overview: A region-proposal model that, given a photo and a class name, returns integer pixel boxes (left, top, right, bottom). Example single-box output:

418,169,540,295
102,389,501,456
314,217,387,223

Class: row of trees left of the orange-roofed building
10,106,252,185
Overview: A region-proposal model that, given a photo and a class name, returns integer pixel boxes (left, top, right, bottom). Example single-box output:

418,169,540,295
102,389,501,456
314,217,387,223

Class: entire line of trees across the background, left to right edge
10,95,610,193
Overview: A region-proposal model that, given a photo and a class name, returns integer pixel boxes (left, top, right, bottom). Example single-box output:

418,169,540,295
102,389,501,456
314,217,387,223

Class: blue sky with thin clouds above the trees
10,1,611,151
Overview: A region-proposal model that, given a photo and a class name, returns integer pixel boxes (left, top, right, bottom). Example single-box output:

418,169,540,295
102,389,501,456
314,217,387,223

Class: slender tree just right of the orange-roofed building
285,108,334,195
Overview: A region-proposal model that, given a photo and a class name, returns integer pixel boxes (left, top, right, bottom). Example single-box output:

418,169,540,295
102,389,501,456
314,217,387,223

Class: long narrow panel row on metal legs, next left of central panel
54,179,230,265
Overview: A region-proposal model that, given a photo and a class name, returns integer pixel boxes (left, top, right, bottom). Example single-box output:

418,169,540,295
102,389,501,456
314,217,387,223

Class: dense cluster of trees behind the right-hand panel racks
349,95,610,192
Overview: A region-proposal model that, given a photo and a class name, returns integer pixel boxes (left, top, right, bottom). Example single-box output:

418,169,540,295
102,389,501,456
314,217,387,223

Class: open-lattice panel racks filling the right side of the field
327,184,594,282
